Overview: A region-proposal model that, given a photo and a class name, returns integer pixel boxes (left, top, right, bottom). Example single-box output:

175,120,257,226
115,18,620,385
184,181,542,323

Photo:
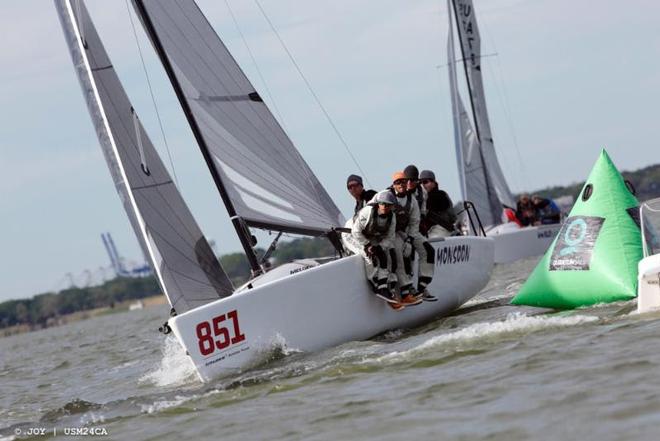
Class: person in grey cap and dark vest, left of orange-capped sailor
351,190,399,305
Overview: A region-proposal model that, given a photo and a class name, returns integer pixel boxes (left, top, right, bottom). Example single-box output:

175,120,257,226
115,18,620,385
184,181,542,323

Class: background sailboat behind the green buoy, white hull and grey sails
447,0,560,263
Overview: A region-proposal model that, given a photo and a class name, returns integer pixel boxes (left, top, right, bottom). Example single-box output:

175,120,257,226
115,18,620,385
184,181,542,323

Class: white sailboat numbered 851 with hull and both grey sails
55,0,494,381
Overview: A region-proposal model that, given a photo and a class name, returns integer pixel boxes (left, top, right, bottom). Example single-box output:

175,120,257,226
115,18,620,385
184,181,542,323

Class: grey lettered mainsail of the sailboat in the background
450,0,515,224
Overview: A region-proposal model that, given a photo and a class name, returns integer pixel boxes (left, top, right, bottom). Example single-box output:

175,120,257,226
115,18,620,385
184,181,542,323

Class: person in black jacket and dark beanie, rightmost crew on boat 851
419,170,456,239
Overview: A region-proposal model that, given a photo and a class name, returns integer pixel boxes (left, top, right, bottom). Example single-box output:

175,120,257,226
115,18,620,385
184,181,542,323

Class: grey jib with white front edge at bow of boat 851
55,0,233,313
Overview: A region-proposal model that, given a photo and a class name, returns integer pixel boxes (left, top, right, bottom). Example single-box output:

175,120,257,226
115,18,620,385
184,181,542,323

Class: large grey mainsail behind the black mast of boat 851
134,0,344,234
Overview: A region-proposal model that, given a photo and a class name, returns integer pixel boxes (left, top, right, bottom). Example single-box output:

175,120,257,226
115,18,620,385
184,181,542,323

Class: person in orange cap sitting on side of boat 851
390,172,435,304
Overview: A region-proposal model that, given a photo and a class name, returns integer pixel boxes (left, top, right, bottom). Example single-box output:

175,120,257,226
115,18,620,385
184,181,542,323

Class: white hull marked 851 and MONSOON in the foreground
169,237,494,381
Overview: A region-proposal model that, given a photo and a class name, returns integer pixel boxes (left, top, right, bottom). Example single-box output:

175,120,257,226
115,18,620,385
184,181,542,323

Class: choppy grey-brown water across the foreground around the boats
0,260,660,440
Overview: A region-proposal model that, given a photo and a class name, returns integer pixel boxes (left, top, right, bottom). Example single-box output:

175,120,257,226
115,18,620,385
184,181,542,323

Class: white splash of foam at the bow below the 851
140,336,197,386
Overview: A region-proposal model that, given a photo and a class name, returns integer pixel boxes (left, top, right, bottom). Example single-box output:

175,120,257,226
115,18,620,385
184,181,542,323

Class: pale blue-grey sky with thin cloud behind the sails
0,0,660,301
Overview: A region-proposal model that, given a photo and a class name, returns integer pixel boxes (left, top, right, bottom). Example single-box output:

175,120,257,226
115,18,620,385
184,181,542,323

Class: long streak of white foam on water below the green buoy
374,312,599,362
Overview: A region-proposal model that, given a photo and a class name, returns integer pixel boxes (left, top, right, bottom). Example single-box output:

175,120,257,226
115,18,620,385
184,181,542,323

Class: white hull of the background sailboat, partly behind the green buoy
486,222,561,263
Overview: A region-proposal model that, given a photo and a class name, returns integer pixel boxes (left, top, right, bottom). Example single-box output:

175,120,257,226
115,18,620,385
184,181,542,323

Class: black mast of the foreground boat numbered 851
134,0,263,274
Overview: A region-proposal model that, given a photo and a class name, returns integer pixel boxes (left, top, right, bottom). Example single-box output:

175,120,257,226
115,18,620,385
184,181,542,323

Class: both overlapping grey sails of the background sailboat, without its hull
448,0,515,225
